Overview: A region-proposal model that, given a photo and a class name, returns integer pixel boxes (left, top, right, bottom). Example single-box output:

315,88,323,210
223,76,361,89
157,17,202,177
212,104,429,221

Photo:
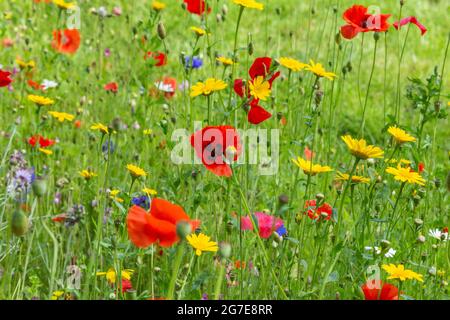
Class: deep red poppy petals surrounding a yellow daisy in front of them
234,57,281,124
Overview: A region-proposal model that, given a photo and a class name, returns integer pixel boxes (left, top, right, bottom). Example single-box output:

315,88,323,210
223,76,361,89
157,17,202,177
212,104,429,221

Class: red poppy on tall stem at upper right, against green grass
341,5,391,39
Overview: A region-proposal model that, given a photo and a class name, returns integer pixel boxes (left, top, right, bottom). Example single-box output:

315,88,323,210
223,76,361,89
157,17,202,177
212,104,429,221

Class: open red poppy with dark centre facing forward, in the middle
191,126,242,177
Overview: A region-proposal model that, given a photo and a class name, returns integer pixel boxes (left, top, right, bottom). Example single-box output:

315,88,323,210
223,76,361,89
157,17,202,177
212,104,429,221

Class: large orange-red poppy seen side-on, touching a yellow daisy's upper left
127,198,200,248
